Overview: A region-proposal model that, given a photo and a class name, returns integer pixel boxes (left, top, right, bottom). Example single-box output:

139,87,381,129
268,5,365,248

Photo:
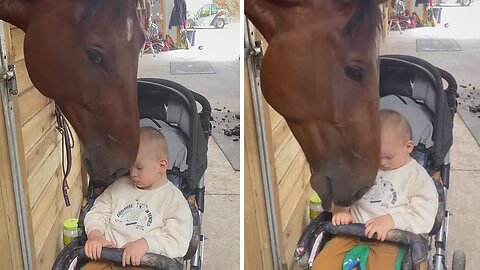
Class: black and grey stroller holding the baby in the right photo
294,55,466,270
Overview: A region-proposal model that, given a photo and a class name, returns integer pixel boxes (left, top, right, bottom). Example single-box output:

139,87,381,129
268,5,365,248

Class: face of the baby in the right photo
380,134,413,171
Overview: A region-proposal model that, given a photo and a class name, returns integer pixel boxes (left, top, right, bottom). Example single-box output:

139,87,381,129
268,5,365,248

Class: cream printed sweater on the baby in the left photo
85,177,193,258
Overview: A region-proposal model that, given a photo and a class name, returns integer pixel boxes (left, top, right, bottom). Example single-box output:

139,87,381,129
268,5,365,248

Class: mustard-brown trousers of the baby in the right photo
312,235,400,270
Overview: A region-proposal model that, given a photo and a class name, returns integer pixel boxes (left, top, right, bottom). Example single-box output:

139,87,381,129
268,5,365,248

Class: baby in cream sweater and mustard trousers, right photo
313,110,438,270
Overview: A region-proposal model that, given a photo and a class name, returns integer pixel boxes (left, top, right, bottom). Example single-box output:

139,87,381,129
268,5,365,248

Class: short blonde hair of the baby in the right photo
380,110,412,142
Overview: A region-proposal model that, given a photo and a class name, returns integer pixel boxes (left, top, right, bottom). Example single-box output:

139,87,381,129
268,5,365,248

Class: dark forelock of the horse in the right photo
343,0,382,41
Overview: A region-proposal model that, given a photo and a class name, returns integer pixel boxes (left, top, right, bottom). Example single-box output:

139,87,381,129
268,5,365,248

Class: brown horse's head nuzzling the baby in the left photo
0,0,145,183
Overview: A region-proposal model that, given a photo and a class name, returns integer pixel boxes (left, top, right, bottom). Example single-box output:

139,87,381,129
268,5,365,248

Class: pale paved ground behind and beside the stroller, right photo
382,1,480,270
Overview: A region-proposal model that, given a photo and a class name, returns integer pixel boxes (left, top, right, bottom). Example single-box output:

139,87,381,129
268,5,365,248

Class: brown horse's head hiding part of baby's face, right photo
245,0,384,209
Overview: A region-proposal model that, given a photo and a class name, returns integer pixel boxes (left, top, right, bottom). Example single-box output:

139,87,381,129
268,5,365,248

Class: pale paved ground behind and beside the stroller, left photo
139,23,240,270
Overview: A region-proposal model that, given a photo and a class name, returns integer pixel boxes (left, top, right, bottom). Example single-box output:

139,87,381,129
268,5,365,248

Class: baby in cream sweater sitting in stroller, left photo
84,127,193,269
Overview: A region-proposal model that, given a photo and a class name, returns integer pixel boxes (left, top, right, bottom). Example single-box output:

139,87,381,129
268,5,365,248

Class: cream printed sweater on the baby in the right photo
350,159,438,234
